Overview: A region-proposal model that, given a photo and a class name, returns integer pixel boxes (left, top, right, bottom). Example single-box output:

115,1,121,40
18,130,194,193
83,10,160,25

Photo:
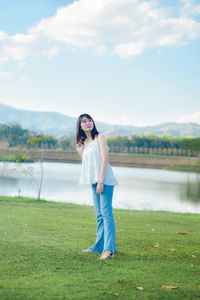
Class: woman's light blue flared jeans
89,183,117,253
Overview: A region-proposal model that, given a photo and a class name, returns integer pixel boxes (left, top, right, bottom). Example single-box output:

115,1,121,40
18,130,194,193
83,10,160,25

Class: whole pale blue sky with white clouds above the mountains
0,0,200,126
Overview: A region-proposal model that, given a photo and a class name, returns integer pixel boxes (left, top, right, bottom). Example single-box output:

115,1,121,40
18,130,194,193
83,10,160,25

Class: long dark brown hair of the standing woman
76,114,99,144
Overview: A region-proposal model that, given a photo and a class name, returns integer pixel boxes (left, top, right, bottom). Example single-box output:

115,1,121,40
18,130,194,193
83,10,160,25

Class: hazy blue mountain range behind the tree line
0,104,200,137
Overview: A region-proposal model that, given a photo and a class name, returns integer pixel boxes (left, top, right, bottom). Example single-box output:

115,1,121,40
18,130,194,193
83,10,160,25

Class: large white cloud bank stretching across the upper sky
0,0,200,64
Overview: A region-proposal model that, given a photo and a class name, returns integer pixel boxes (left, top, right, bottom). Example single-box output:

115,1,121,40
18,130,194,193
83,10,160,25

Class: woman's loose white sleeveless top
79,138,119,185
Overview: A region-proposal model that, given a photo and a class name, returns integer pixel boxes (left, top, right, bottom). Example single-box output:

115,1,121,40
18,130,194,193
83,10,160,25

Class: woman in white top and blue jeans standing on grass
76,114,118,259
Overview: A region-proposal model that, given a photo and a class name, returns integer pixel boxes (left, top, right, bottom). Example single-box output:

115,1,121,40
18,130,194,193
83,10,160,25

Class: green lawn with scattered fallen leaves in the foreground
0,197,200,300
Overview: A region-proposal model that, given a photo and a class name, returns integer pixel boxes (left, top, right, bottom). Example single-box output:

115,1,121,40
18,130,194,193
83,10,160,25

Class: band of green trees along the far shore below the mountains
0,123,200,156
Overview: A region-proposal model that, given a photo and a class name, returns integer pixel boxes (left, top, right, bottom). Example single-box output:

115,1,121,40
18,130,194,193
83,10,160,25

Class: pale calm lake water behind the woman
0,163,200,213
